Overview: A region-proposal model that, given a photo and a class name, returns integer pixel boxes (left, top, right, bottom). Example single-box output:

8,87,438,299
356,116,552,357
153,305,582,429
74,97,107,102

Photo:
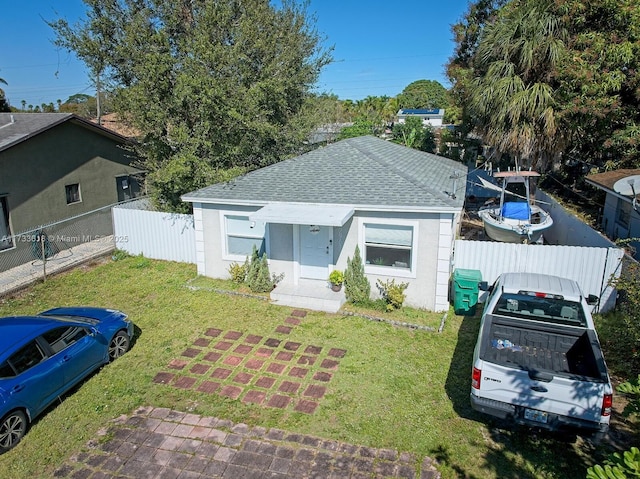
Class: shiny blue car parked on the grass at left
0,307,133,454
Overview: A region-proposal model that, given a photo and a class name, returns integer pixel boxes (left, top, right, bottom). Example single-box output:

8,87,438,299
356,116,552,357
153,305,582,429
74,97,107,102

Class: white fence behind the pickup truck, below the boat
452,240,624,312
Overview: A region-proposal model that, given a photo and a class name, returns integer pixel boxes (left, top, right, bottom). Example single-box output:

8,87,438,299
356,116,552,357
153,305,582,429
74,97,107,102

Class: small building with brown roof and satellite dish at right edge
585,169,640,258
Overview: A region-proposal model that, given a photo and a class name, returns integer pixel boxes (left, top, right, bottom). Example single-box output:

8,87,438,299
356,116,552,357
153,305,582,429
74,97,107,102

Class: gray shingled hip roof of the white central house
182,136,467,211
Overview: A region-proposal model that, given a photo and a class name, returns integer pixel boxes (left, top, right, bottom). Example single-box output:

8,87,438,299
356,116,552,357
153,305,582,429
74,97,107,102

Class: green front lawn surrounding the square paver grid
0,257,620,478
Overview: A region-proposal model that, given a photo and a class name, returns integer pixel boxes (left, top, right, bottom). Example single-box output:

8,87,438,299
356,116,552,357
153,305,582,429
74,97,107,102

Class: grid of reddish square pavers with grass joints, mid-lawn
153,310,347,414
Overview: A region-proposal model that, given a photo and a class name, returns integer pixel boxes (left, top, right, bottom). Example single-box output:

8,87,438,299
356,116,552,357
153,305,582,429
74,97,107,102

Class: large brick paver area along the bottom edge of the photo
54,407,440,479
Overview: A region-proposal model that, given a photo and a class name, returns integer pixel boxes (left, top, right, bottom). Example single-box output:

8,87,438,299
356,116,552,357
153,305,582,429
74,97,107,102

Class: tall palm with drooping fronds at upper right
469,0,567,170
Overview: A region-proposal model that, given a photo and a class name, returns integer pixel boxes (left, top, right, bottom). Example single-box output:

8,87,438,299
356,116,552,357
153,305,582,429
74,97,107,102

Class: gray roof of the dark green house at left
0,113,127,151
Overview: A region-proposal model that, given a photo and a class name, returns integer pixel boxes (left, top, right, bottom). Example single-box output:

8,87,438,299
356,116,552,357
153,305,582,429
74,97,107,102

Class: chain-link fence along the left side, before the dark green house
0,205,114,286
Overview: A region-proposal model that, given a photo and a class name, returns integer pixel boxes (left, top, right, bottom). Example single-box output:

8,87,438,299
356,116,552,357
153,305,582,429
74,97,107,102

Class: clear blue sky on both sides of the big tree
0,0,468,108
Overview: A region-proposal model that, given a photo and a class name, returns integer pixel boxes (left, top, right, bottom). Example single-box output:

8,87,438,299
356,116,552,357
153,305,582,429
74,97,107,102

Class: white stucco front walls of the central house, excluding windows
194,204,459,311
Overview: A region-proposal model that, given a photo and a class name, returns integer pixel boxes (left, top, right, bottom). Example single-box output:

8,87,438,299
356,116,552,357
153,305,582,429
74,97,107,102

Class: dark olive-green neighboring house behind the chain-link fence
0,113,140,270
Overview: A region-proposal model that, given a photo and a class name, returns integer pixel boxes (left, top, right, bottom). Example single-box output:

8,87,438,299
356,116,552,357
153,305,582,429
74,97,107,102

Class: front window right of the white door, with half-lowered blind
364,223,414,270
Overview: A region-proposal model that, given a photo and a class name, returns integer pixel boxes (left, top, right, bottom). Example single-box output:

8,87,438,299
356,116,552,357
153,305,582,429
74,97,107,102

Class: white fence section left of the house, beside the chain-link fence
112,199,196,264
